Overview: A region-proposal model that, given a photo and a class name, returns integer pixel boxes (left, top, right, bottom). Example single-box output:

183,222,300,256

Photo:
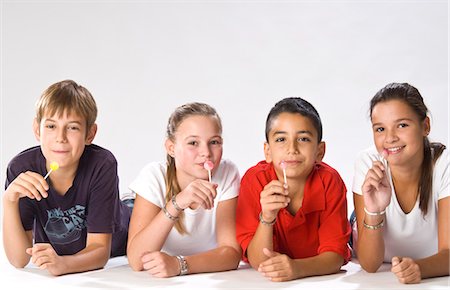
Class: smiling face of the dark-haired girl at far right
371,99,430,166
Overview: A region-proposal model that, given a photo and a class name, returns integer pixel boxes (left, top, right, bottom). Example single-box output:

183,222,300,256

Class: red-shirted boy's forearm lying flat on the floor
295,252,344,278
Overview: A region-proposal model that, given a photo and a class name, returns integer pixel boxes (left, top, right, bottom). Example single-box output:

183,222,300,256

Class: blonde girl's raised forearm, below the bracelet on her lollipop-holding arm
127,206,174,271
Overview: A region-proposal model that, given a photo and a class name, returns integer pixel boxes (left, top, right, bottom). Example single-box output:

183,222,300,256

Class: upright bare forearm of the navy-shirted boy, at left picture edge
3,198,32,268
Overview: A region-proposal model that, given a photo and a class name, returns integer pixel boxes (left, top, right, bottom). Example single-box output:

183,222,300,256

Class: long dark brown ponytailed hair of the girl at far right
370,83,445,216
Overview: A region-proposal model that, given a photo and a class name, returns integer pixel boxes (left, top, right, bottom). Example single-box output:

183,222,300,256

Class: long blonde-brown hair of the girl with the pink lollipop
166,103,222,234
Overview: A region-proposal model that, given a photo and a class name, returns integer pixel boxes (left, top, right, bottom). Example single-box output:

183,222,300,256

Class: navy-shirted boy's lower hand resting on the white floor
26,243,65,276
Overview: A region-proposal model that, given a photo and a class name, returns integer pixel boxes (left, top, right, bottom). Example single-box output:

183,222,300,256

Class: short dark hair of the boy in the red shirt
266,97,322,142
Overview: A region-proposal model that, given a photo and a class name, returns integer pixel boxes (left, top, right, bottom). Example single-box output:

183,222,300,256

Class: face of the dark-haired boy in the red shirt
264,113,325,180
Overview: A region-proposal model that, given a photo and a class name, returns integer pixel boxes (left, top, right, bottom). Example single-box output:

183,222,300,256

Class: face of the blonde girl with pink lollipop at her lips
166,115,223,188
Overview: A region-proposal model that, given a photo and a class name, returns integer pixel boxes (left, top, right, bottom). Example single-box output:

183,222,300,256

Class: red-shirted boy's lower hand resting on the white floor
258,248,297,282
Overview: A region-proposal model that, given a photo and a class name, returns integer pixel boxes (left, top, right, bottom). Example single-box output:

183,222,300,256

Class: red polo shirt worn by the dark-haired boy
236,161,350,263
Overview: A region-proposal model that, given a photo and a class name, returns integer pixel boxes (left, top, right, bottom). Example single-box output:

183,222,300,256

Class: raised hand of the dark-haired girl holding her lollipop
362,161,392,212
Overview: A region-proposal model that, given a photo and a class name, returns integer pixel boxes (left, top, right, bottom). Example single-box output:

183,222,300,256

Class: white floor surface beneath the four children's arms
0,249,450,290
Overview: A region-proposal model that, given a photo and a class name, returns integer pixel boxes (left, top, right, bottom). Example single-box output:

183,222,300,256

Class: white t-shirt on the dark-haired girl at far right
353,147,450,262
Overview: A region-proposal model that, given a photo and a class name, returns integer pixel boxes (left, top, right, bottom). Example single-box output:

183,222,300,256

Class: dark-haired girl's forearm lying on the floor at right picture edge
415,249,450,279
